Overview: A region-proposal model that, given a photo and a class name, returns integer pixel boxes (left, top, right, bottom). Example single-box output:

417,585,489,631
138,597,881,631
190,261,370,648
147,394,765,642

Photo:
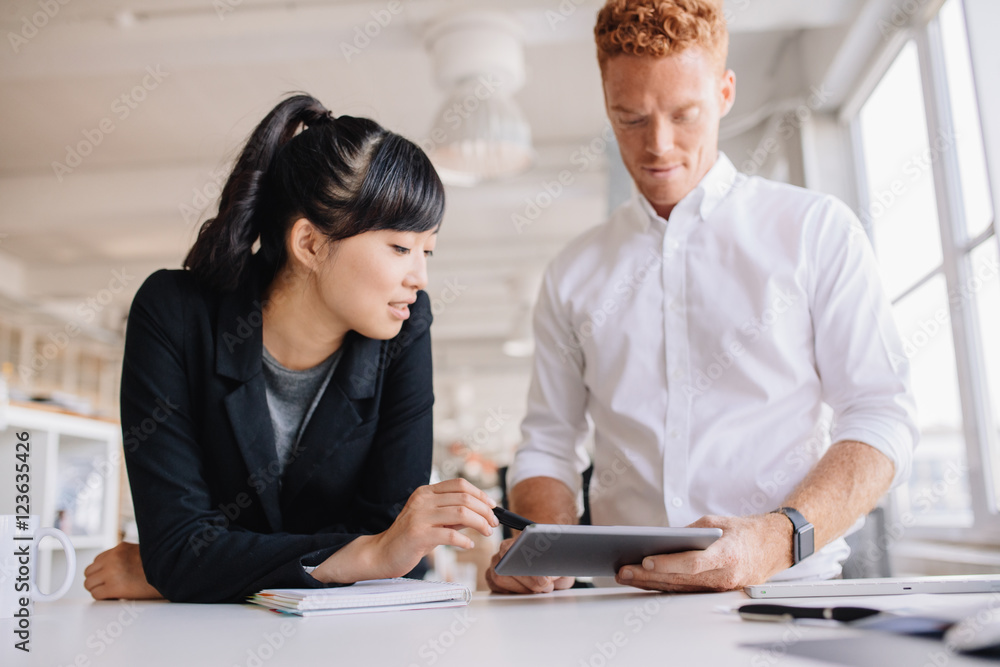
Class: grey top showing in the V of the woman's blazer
263,347,343,478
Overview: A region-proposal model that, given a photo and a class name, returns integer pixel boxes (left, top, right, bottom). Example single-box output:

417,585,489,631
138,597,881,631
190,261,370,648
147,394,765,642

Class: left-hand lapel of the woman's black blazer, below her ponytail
215,290,282,532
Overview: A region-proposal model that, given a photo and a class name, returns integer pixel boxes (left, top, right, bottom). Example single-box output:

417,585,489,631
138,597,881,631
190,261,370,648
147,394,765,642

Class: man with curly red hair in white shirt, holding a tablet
487,0,917,593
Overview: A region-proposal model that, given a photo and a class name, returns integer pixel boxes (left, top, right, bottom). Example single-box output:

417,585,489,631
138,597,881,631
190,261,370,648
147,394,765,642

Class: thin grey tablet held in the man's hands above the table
496,523,722,577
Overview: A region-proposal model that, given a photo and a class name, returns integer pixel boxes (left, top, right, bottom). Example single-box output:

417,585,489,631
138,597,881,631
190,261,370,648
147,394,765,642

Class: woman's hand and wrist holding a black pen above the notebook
312,479,499,583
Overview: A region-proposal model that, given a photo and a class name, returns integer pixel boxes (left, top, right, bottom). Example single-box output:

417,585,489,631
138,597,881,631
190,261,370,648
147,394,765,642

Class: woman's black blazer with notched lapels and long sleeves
121,270,434,602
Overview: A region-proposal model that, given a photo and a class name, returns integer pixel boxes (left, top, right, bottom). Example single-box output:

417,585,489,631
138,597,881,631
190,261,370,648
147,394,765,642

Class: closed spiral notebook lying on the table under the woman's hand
247,579,472,616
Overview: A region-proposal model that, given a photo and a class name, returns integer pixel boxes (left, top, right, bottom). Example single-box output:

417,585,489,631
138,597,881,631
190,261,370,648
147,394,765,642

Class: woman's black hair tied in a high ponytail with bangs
184,95,444,291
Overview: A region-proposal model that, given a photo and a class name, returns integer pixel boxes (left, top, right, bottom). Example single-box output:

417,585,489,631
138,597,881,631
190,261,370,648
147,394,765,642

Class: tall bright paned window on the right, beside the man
853,0,1000,534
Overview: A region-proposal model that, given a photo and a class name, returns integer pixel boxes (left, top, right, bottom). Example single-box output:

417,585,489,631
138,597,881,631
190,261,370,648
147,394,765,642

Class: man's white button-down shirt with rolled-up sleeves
508,154,918,579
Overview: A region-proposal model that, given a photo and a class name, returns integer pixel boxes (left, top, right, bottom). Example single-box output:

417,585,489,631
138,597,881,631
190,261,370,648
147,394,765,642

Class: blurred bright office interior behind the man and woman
0,0,1000,592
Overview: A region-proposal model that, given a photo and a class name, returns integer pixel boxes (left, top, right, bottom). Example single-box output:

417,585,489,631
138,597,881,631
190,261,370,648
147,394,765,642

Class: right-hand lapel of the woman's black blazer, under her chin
282,331,383,505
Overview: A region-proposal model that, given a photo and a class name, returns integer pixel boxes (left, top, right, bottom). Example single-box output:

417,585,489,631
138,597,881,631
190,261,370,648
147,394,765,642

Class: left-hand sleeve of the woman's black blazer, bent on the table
121,272,357,602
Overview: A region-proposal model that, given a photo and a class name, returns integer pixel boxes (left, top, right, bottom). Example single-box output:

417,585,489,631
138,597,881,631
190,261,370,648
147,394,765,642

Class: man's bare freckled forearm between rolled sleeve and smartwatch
783,441,895,550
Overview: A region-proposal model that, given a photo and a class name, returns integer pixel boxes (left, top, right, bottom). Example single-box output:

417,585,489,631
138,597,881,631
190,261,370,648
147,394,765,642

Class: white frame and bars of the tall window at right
840,0,1000,545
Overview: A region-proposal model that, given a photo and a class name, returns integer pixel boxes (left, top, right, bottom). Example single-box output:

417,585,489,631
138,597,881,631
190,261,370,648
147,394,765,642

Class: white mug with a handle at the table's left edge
0,514,76,618
